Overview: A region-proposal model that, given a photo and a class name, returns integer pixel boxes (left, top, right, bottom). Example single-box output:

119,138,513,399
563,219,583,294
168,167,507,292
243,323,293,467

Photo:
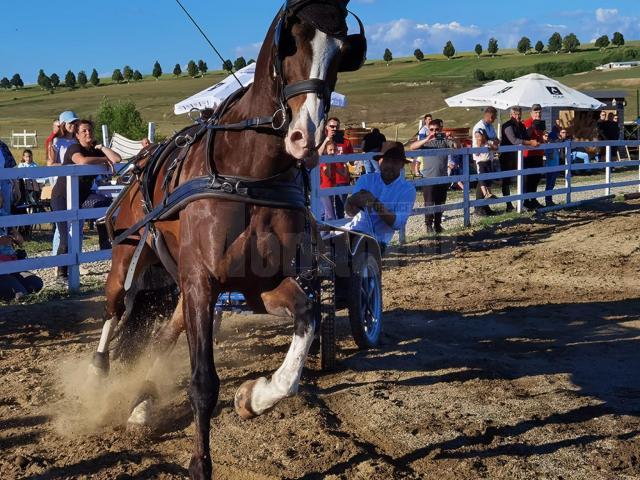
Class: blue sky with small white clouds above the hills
0,0,640,83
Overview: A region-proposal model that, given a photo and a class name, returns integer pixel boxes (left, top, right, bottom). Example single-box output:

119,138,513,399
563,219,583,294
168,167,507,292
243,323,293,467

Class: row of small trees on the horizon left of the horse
0,57,255,92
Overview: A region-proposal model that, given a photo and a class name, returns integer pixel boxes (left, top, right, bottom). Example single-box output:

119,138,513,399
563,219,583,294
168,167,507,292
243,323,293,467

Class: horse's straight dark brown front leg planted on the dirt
180,264,220,480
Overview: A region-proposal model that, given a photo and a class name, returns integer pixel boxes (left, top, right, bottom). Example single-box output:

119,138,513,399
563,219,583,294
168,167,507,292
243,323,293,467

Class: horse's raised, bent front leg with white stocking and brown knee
235,278,314,419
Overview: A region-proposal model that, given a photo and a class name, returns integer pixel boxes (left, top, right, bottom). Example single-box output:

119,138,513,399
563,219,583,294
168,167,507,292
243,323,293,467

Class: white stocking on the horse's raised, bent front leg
251,325,313,415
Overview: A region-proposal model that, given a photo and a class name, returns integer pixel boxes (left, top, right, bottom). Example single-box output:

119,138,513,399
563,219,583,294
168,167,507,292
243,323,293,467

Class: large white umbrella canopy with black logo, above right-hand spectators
446,73,605,110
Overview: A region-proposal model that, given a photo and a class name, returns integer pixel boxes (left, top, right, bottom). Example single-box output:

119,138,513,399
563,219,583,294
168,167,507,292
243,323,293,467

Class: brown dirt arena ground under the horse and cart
0,197,640,480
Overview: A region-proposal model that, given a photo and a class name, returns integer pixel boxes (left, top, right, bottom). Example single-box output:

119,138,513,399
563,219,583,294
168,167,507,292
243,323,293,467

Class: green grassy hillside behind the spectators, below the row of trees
0,41,640,162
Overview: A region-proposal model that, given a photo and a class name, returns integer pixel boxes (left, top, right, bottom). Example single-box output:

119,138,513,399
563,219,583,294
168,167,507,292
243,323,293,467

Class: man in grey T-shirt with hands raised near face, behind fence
409,119,458,234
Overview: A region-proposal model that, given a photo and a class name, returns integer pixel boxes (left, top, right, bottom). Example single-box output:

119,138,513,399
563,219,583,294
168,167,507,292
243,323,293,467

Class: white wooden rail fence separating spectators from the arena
0,140,640,291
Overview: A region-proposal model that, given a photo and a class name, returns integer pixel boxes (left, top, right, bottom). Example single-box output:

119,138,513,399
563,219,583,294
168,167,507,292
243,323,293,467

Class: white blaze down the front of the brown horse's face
285,30,342,156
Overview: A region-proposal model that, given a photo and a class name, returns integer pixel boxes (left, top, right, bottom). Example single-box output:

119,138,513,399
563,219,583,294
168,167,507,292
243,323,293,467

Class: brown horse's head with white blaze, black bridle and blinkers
258,0,367,159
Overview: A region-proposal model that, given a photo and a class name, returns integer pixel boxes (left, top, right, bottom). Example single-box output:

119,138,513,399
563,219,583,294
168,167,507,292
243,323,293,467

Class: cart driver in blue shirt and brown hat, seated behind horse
346,142,416,254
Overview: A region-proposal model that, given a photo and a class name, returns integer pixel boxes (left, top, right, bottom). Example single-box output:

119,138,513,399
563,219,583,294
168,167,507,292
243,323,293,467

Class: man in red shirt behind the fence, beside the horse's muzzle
319,117,353,220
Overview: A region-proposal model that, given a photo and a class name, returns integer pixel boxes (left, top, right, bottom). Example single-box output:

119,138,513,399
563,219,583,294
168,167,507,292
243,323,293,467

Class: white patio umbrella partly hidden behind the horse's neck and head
173,63,347,115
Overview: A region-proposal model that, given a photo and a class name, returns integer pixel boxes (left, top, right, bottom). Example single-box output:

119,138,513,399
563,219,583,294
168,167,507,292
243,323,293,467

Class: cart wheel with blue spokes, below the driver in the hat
348,252,382,350
